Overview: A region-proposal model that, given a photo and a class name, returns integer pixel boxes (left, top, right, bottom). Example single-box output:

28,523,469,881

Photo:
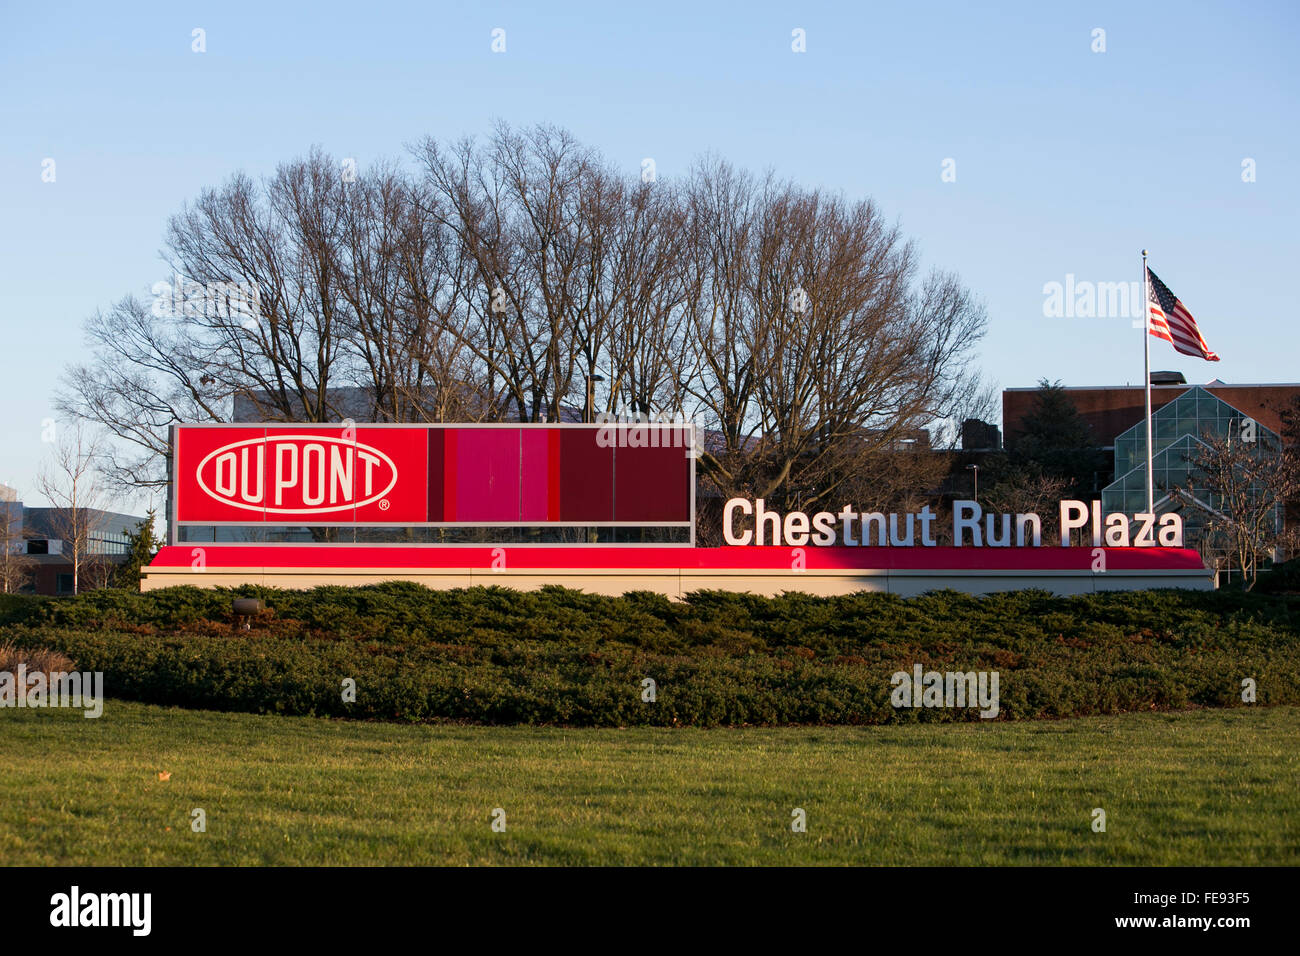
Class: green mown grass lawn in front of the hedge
0,700,1300,865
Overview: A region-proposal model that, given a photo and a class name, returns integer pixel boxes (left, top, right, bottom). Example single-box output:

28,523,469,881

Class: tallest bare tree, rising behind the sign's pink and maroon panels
417,125,595,421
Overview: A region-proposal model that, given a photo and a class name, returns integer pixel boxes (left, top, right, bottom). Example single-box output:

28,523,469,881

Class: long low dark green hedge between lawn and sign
0,583,1300,726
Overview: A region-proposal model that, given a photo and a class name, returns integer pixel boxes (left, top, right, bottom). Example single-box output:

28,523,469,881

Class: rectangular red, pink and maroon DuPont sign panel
174,425,694,525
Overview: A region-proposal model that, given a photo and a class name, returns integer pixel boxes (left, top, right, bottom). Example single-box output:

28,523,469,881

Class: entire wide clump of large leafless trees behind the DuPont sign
61,125,985,522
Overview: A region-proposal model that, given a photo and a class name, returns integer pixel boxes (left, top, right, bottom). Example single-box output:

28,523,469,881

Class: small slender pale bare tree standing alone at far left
36,421,103,594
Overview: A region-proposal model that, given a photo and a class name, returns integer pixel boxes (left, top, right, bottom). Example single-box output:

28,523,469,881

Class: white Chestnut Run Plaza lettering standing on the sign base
723,498,1183,548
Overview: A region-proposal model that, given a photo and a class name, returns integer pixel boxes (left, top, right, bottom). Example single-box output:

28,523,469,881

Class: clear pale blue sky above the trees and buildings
0,0,1300,505
